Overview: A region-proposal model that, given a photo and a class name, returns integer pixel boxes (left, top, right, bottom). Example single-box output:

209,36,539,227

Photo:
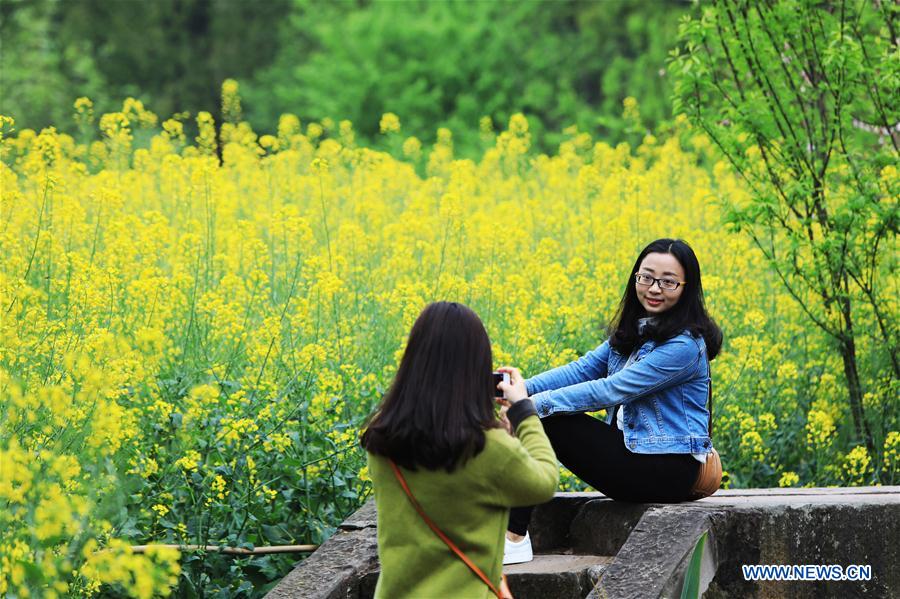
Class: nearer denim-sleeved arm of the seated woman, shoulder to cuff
532,335,703,418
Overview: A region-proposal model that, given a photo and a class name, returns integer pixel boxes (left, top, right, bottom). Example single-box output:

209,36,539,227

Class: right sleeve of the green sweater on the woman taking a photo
495,415,559,507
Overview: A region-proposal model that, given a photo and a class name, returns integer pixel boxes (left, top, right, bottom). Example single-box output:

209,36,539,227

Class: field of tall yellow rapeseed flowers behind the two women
0,82,900,597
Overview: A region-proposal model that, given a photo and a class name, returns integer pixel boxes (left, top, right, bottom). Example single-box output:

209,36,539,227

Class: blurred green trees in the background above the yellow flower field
0,0,689,156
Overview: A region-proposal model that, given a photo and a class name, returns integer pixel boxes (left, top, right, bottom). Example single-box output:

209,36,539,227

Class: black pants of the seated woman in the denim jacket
509,414,700,535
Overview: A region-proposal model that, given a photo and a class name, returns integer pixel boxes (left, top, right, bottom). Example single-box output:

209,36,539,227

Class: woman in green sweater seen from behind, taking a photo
362,302,559,598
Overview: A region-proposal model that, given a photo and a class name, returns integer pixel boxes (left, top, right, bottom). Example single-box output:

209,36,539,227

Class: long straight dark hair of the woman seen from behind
361,302,500,472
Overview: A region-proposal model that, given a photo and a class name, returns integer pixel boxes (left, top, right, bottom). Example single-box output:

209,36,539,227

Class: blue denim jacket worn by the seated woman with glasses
525,331,712,454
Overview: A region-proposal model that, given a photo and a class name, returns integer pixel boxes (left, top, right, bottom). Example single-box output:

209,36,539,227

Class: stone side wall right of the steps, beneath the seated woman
592,486,900,599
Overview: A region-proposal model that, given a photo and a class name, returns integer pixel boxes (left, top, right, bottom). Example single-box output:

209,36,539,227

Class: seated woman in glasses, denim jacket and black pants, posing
500,239,722,563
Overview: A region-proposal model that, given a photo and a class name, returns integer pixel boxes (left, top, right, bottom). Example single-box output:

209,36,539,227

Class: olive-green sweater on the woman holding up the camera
368,415,559,599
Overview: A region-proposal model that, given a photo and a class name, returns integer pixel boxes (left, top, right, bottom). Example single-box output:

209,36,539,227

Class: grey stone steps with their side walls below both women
267,486,900,599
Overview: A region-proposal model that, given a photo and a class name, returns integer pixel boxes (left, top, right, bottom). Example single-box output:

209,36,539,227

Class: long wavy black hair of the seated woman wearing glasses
609,239,722,360
